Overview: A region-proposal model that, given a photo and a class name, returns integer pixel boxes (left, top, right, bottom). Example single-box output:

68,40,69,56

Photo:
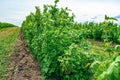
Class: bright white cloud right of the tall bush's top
59,0,120,15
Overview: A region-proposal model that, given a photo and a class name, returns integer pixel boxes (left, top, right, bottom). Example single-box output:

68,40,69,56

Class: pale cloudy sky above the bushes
0,0,120,26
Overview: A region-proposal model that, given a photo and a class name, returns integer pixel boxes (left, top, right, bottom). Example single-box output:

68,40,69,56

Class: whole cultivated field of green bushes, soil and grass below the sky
0,0,120,80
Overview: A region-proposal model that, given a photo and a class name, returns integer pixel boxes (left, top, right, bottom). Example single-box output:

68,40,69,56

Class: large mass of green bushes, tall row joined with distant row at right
22,0,120,80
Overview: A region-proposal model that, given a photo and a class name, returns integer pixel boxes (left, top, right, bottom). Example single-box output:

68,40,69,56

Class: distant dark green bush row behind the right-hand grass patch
77,21,120,44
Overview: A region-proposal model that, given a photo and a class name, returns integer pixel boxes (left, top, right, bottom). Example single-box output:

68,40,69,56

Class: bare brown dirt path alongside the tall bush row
11,34,42,80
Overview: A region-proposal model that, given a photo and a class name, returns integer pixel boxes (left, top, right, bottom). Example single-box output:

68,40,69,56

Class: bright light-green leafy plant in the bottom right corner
90,45,120,80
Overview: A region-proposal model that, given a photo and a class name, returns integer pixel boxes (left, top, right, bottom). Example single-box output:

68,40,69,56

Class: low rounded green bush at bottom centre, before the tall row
58,43,93,80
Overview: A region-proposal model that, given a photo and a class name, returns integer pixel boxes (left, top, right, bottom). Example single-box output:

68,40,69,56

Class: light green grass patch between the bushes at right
87,39,118,59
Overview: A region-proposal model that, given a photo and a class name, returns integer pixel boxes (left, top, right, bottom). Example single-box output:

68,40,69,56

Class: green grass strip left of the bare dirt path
0,27,19,80
